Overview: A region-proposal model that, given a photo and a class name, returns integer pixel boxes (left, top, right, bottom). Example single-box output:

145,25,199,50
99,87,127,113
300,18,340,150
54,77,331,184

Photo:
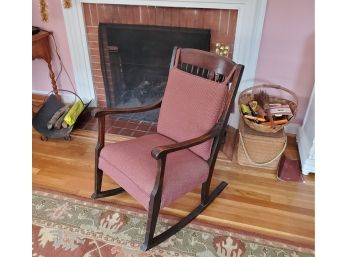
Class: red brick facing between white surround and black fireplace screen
82,3,238,107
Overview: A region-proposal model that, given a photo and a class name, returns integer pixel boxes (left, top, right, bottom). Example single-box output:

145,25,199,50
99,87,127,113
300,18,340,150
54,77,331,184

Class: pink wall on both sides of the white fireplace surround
32,0,314,124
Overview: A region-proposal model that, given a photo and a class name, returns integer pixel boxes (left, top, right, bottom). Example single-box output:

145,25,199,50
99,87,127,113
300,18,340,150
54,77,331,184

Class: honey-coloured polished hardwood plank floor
32,130,314,247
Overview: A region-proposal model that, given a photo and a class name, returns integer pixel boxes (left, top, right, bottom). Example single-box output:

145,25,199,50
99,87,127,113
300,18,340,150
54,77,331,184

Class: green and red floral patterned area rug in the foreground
32,190,314,257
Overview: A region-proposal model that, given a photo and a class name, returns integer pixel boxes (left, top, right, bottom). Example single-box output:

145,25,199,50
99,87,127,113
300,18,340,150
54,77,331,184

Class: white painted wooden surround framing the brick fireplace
63,0,267,128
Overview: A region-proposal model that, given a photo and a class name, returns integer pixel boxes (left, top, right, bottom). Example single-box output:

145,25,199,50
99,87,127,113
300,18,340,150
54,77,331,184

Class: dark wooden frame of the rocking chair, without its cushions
91,47,244,251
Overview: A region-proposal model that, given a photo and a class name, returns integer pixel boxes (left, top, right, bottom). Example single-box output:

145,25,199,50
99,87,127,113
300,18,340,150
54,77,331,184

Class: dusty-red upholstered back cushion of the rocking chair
157,67,227,160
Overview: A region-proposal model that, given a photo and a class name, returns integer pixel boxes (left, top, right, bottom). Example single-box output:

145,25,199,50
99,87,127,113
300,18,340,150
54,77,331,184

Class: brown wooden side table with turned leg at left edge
32,31,58,95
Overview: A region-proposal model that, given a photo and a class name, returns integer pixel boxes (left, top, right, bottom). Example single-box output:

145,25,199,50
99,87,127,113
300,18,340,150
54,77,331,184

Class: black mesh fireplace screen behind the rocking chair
99,23,210,121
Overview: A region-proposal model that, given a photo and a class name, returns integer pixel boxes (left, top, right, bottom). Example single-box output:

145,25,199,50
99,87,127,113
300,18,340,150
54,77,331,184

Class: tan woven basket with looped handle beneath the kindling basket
237,118,287,170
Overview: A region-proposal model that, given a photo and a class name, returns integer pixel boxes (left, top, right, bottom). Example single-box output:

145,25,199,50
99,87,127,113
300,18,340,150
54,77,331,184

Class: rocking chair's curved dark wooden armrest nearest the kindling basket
151,124,221,160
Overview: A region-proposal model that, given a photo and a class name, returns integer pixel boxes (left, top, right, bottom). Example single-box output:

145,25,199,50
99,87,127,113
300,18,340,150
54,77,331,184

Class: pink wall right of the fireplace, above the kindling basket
255,0,314,124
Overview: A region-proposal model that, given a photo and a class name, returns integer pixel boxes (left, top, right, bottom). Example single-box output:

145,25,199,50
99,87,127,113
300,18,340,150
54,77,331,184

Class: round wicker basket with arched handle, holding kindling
238,85,298,133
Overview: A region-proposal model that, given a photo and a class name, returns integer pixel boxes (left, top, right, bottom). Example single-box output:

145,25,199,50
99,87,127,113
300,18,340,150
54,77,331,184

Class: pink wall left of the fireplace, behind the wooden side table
32,0,75,91
